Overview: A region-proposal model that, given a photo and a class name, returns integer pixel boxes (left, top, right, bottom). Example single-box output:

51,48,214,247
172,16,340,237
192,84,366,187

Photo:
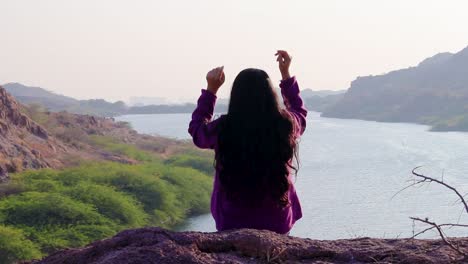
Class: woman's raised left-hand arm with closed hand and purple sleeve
188,67,224,149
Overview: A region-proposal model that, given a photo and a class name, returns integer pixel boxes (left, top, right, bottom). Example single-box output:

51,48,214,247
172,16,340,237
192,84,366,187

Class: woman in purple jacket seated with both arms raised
188,50,307,234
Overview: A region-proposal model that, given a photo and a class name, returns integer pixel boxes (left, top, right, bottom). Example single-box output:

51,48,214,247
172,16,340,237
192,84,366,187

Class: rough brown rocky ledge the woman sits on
32,228,468,264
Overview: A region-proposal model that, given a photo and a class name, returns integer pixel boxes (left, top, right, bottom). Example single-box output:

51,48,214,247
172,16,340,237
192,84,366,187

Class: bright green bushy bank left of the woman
0,155,212,263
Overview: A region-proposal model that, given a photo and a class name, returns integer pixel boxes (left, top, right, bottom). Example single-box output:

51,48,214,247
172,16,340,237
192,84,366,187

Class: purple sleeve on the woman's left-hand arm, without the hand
188,89,219,149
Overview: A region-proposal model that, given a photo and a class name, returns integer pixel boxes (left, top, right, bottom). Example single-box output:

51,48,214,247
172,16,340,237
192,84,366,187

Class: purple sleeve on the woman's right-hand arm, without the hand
280,77,307,136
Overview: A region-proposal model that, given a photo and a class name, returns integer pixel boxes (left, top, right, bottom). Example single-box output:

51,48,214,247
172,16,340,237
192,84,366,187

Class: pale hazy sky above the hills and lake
0,0,468,100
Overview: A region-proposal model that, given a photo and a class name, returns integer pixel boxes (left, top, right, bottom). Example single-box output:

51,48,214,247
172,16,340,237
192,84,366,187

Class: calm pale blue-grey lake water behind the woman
118,113,468,239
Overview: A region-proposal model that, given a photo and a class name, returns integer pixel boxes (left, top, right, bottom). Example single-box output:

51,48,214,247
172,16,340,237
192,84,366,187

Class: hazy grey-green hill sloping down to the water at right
322,47,468,131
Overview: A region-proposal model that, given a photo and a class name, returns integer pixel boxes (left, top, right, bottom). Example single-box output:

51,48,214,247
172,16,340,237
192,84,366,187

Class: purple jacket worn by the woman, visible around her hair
188,77,307,234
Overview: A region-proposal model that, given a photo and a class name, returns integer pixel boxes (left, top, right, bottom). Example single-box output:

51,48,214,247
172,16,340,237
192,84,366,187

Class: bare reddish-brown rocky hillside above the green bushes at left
0,87,190,181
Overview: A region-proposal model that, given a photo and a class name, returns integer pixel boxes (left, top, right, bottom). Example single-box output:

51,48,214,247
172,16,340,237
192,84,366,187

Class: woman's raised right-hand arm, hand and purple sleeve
275,50,307,136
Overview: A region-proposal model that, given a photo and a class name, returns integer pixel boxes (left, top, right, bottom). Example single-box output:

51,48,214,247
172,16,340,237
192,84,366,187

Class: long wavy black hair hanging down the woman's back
215,69,298,207
